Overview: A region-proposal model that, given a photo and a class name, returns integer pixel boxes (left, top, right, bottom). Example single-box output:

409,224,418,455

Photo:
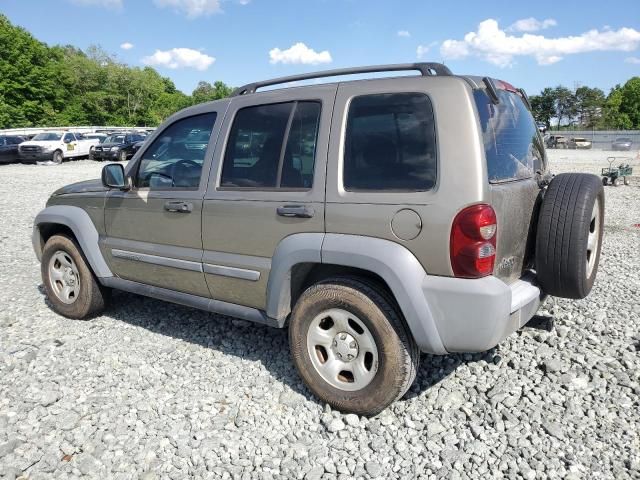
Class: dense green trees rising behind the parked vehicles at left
0,15,232,128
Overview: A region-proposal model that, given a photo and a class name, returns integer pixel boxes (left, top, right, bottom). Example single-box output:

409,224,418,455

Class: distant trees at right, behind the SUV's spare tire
529,77,640,130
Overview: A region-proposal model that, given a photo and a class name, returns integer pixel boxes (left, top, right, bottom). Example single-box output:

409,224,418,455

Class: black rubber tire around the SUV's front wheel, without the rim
40,235,110,319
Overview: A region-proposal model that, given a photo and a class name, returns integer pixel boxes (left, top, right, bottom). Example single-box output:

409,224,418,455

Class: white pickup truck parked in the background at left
18,132,100,163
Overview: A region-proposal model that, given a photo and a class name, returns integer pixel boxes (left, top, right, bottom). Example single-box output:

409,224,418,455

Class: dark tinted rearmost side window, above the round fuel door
343,93,436,191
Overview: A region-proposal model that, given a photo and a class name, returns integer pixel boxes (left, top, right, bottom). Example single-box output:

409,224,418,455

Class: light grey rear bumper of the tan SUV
422,275,541,352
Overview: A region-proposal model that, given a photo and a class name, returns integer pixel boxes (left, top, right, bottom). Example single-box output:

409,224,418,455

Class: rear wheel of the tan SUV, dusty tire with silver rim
289,277,420,415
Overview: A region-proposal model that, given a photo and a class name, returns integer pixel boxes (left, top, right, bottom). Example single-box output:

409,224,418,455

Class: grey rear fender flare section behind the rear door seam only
322,233,447,355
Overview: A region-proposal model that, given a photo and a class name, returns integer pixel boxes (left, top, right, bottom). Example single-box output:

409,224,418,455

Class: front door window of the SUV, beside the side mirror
136,112,216,190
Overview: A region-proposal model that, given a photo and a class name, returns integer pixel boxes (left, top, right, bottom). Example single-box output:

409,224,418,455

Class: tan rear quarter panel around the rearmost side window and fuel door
326,77,489,276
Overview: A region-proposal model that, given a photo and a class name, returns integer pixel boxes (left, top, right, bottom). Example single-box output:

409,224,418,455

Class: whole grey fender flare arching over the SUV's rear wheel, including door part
267,233,447,354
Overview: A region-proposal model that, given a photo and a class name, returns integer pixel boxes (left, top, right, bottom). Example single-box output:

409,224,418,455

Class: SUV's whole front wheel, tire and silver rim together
41,235,109,319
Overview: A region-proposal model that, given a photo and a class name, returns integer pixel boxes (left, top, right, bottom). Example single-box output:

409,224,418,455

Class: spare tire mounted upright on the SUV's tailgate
536,173,604,299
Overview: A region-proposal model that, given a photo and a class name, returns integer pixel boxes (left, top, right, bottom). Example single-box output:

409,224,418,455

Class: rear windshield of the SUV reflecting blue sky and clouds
474,90,544,183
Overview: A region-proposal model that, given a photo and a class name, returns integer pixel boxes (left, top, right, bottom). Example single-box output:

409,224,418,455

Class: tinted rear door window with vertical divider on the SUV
220,102,320,189
